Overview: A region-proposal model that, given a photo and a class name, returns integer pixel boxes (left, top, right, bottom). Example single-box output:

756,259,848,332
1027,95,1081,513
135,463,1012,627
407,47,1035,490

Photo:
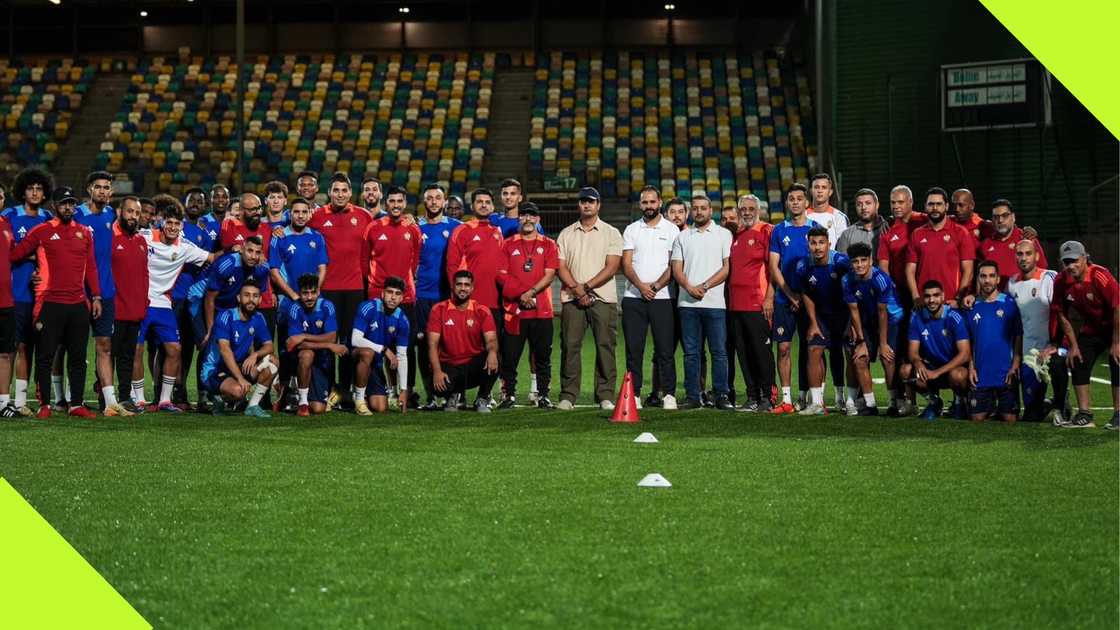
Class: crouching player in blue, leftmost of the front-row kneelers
203,278,277,418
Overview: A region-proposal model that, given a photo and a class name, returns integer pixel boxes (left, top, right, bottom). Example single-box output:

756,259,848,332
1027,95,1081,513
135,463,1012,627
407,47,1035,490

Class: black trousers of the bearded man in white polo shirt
623,297,680,396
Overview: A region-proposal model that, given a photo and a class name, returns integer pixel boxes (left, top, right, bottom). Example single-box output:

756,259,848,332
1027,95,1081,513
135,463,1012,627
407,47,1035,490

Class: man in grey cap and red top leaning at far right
1043,241,1120,429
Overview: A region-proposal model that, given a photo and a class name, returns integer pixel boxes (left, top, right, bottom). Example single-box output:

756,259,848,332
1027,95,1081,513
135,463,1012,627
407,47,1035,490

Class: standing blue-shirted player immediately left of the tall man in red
269,198,328,410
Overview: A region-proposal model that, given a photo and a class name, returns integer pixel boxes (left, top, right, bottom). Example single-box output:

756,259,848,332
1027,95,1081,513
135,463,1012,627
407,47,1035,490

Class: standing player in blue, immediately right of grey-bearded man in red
769,183,816,414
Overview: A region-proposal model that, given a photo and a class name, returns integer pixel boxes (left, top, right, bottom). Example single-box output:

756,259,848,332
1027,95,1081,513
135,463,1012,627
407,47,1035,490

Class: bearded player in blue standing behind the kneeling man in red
411,184,463,410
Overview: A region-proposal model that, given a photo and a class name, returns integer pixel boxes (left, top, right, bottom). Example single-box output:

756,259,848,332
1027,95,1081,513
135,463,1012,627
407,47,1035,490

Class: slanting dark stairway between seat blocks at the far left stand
55,74,129,188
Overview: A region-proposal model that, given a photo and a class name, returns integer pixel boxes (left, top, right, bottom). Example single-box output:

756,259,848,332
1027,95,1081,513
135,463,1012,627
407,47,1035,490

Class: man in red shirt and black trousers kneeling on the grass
426,269,497,414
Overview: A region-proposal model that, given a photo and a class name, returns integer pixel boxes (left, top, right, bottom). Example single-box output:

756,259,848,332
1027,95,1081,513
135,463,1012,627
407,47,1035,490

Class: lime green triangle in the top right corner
980,0,1120,138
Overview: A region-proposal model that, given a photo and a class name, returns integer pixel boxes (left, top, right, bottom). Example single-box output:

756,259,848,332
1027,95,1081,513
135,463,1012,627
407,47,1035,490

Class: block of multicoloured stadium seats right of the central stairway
529,52,815,215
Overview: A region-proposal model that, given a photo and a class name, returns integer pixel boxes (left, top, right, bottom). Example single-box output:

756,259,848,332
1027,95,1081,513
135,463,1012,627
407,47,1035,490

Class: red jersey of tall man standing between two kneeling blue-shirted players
307,204,371,291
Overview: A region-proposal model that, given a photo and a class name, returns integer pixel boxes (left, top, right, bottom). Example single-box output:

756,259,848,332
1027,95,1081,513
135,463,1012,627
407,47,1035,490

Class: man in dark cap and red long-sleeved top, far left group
11,186,101,418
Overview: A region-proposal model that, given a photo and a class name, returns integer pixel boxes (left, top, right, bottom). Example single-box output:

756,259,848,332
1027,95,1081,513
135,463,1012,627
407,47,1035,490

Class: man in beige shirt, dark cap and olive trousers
557,186,623,410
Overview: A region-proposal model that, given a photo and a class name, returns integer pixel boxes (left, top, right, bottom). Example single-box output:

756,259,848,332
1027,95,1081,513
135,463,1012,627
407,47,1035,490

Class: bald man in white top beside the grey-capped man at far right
1007,240,1067,421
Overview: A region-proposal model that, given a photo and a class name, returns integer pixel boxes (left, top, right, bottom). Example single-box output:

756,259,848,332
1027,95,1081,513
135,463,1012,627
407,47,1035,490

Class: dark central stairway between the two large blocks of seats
483,67,534,188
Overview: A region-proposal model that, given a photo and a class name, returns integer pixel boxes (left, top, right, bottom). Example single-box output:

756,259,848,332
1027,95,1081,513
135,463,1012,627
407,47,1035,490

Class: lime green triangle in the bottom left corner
0,478,151,629
